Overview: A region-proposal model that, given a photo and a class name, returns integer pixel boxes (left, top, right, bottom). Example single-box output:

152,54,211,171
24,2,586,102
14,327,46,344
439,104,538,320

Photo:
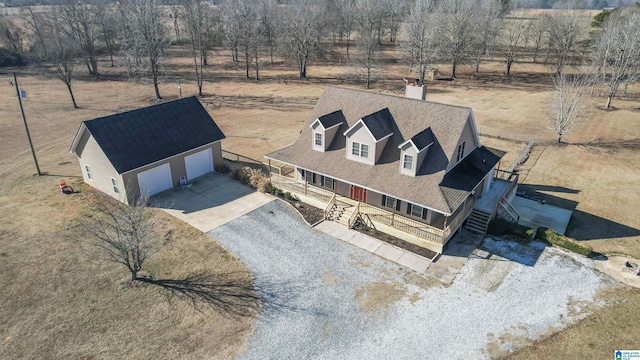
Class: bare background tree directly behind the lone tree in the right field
543,3,589,74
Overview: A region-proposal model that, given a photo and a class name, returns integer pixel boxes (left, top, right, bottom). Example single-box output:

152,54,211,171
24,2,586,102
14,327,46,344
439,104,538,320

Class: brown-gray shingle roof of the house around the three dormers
266,86,496,214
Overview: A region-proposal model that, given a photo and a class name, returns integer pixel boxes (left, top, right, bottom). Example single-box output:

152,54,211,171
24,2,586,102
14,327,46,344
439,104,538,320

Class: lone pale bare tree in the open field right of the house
550,70,591,143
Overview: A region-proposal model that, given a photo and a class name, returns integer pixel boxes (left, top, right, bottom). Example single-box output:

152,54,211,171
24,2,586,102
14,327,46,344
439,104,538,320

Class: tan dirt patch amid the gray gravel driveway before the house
354,277,408,318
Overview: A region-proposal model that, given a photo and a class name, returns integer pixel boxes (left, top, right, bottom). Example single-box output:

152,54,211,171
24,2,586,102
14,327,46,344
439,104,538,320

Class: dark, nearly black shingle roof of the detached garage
84,96,225,174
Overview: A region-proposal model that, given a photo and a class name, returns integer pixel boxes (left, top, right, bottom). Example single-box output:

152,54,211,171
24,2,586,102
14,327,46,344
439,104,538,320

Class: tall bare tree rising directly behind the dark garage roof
119,0,169,100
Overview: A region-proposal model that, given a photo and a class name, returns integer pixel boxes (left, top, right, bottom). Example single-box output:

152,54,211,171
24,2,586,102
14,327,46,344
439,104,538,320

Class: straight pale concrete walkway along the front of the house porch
314,221,431,274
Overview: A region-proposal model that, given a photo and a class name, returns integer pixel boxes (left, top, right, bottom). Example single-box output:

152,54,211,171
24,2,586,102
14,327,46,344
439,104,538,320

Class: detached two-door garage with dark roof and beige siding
69,97,225,203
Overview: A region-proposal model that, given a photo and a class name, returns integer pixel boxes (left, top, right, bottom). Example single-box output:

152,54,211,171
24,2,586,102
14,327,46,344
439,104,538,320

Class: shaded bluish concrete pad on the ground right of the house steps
511,196,573,234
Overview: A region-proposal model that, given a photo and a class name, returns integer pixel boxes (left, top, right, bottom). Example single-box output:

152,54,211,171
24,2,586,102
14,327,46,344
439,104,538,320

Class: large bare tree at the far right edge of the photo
593,9,640,109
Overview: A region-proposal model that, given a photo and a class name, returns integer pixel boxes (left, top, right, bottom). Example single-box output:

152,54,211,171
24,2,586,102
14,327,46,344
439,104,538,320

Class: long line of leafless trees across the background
0,0,640,112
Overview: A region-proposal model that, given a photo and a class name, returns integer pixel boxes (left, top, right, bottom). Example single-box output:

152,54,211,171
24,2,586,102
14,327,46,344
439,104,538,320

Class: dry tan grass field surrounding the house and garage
0,4,640,359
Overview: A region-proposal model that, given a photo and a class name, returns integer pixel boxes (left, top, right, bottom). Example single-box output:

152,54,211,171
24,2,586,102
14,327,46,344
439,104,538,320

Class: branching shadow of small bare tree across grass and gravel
139,272,309,317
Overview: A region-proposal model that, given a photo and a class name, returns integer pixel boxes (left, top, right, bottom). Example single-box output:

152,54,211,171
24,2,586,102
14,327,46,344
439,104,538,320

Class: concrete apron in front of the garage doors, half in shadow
156,173,275,233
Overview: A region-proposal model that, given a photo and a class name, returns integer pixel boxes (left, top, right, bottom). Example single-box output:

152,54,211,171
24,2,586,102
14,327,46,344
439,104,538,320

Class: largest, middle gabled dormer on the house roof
344,108,393,165
